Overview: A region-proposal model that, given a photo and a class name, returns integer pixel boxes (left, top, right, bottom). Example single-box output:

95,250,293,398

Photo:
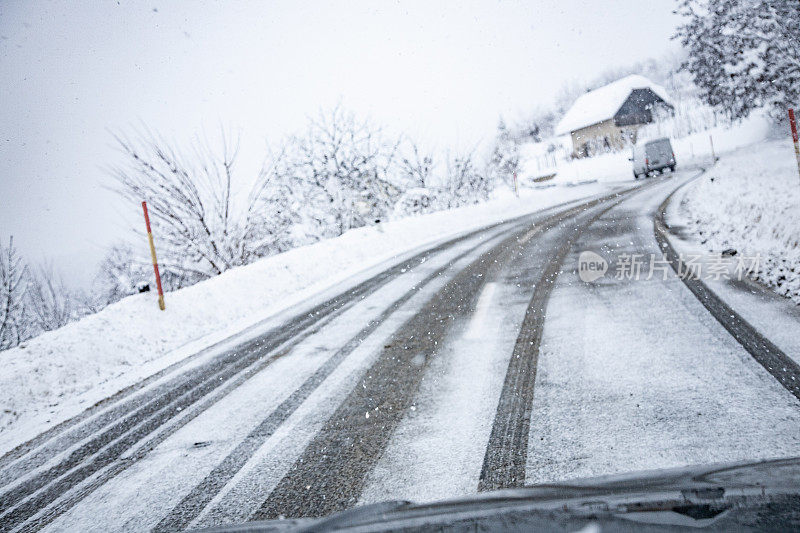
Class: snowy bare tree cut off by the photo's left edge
0,237,29,350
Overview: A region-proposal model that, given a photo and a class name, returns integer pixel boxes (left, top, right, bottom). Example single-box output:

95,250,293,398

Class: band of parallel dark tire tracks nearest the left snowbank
0,189,640,531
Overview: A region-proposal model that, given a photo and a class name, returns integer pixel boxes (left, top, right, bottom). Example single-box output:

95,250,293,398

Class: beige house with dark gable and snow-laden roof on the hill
555,74,672,157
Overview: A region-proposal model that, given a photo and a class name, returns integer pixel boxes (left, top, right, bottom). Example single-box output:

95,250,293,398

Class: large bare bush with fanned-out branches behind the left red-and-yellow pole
112,127,284,281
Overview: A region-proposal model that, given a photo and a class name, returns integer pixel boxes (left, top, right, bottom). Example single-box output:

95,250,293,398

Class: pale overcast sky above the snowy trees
0,0,677,286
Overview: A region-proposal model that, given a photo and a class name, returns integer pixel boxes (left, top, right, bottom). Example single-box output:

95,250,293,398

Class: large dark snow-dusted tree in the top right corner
676,0,800,118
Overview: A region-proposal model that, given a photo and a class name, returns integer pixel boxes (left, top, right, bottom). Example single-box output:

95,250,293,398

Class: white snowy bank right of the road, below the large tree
679,138,800,304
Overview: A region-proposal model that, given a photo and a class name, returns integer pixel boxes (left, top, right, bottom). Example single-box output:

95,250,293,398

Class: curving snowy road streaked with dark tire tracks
0,172,800,531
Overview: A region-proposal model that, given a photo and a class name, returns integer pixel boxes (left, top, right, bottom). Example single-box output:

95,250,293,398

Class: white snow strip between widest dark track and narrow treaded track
360,282,530,504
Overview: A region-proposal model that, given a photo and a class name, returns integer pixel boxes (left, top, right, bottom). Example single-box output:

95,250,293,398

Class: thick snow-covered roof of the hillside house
556,74,671,135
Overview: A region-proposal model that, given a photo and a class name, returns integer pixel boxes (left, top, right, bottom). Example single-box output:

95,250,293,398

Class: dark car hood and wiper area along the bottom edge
194,457,800,532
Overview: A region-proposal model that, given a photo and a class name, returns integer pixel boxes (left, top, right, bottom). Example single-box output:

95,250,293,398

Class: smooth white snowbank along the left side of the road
0,180,632,453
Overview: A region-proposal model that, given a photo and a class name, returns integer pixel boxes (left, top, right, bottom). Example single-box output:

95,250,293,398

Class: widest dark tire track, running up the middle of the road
253,189,630,520
